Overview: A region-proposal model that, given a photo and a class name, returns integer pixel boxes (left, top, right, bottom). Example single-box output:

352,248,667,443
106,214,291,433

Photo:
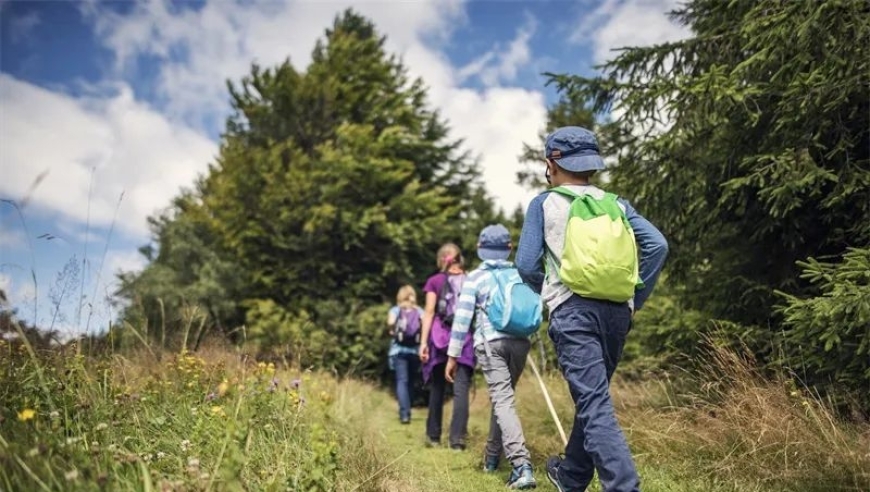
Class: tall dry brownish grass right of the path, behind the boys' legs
510,347,870,492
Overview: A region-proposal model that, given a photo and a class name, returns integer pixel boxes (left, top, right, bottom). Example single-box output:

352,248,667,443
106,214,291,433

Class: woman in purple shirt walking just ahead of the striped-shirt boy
420,243,475,450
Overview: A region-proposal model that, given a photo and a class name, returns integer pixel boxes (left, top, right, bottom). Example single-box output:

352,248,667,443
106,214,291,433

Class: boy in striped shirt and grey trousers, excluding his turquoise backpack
445,224,537,489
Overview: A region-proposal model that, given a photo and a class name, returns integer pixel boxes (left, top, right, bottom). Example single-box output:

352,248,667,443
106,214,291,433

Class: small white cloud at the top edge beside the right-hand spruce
571,0,690,63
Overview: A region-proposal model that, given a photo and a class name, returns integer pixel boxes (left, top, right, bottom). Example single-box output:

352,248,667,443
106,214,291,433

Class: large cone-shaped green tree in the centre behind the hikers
121,11,502,374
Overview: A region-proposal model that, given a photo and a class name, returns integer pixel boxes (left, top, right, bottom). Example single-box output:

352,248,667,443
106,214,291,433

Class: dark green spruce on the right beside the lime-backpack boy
552,0,870,408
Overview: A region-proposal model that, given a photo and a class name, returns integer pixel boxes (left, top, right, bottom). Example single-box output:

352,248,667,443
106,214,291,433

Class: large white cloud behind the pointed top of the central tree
82,0,546,210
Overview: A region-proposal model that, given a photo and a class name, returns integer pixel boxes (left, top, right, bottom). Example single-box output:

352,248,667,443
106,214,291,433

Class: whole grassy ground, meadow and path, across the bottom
0,340,870,492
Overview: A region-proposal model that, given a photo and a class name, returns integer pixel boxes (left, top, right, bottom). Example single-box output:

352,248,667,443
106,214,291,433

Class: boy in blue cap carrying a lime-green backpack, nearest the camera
516,126,668,492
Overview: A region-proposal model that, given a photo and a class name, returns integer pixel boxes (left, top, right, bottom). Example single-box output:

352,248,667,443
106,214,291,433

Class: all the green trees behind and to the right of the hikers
100,0,870,411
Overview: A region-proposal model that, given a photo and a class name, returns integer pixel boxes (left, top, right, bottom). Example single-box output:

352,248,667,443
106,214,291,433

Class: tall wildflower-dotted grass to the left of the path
0,340,398,491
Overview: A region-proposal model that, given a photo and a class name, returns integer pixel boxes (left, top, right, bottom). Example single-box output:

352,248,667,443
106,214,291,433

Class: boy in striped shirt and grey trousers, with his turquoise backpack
446,224,541,489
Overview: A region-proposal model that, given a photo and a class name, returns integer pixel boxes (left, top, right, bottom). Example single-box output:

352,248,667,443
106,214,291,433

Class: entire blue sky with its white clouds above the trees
0,0,686,333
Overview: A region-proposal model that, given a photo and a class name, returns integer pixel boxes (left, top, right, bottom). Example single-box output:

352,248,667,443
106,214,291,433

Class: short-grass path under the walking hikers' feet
346,374,770,492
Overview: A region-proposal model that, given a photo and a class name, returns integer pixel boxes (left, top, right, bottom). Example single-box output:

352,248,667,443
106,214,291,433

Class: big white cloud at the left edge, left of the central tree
0,74,217,237
